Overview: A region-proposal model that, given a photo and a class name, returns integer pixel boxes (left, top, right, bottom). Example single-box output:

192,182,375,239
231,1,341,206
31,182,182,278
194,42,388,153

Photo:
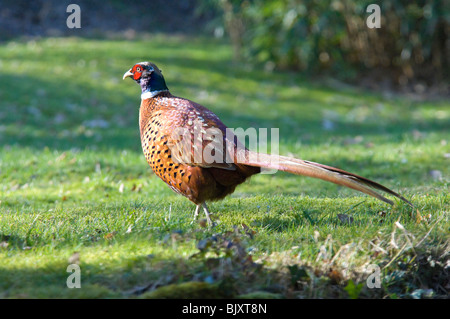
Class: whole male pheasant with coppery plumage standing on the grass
123,62,412,224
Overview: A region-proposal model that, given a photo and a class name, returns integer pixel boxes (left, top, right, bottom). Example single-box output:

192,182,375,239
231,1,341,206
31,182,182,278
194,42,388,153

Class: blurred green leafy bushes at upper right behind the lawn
206,0,450,90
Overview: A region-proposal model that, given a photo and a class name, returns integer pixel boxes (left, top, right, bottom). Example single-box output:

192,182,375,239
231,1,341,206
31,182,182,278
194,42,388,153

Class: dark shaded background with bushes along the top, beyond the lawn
0,0,450,93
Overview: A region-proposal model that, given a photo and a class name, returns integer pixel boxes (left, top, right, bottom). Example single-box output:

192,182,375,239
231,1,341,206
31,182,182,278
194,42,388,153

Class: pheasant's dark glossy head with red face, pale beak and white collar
123,62,169,98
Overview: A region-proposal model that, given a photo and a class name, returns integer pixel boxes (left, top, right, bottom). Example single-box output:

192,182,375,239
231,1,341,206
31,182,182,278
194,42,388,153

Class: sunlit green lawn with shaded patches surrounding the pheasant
0,35,450,298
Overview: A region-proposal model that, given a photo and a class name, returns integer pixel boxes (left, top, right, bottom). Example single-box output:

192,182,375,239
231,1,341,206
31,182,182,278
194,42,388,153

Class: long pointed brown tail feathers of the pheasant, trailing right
239,151,414,207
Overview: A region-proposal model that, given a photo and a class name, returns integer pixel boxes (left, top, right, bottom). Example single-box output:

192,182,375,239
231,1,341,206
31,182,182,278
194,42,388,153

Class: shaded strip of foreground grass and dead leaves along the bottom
0,225,448,299
